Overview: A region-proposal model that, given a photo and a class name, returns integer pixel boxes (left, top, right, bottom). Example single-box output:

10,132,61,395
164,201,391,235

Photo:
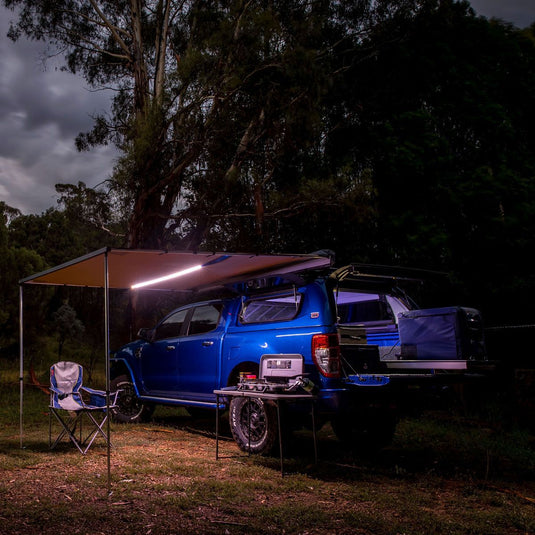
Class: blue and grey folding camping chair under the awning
48,361,118,455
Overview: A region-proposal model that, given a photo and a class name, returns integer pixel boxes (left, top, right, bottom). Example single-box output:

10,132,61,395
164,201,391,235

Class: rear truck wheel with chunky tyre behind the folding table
229,397,277,455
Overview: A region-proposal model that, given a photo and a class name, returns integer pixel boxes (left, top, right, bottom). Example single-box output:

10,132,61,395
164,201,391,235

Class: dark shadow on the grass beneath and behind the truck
134,409,535,482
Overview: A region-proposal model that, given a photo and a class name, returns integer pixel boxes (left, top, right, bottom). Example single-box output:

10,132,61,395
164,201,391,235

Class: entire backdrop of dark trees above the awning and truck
4,0,535,340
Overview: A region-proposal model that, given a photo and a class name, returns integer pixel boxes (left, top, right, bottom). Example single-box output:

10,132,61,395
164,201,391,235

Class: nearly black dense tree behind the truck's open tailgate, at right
338,1,535,322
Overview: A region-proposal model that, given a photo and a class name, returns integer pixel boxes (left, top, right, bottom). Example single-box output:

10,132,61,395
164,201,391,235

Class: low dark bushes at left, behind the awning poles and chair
0,199,122,359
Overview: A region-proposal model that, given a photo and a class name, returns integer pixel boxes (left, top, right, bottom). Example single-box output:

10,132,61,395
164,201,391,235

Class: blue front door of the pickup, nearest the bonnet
138,309,188,396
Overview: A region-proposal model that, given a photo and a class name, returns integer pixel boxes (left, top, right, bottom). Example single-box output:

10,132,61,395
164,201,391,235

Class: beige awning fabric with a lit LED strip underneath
19,248,330,291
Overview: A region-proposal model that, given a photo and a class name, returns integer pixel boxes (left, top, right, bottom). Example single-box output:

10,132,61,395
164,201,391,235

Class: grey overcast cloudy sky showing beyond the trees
0,0,535,214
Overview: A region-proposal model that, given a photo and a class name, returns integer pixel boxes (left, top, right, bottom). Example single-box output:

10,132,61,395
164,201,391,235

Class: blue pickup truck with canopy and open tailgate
111,266,486,453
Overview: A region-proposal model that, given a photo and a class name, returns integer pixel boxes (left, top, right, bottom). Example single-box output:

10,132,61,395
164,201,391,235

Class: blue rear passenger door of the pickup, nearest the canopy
178,303,224,401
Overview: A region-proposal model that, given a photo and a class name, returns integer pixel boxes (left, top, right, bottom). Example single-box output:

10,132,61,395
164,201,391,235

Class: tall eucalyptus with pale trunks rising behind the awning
4,0,425,248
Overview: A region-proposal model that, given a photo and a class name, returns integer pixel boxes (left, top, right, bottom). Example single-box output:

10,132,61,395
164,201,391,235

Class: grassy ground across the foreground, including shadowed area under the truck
0,370,535,535
